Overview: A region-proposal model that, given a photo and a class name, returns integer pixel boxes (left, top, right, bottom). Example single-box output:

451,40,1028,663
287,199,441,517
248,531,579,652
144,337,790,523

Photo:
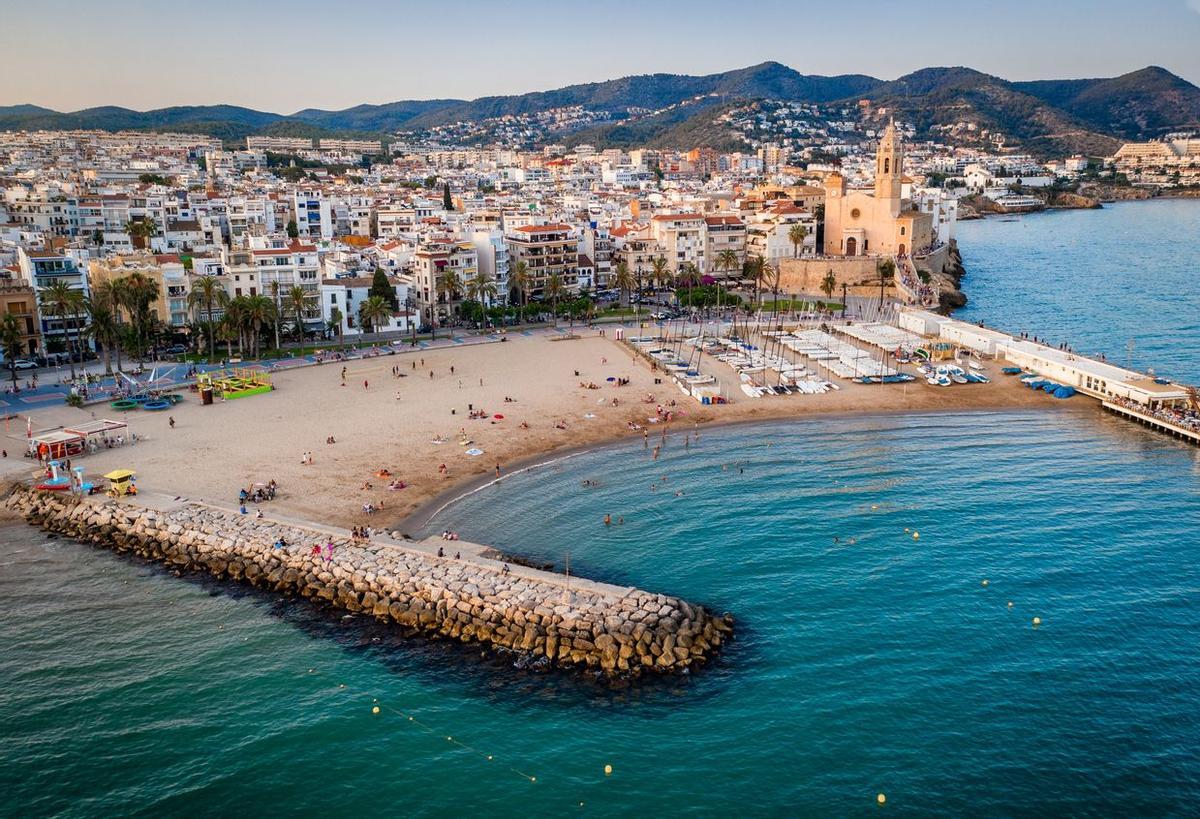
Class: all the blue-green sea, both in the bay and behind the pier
0,195,1200,817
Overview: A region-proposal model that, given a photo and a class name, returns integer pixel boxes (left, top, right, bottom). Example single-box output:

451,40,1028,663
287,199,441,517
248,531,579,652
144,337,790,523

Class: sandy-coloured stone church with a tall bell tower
824,124,934,256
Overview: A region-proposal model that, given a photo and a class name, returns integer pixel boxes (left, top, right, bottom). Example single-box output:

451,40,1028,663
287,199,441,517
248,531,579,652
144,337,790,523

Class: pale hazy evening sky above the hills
9,0,1200,113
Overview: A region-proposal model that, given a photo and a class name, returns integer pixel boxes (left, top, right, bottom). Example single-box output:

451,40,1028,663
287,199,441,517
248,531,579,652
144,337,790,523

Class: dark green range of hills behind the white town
0,62,1200,155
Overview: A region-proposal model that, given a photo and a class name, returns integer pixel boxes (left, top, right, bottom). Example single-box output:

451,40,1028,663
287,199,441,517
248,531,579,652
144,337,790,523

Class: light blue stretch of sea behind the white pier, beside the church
955,199,1200,384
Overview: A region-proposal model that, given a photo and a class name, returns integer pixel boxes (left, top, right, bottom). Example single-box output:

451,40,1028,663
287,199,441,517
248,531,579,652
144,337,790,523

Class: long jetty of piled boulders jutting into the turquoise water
5,485,733,677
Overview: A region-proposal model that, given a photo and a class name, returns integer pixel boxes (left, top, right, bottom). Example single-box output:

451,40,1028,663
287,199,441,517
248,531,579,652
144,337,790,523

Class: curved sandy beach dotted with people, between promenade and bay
7,330,1062,533
